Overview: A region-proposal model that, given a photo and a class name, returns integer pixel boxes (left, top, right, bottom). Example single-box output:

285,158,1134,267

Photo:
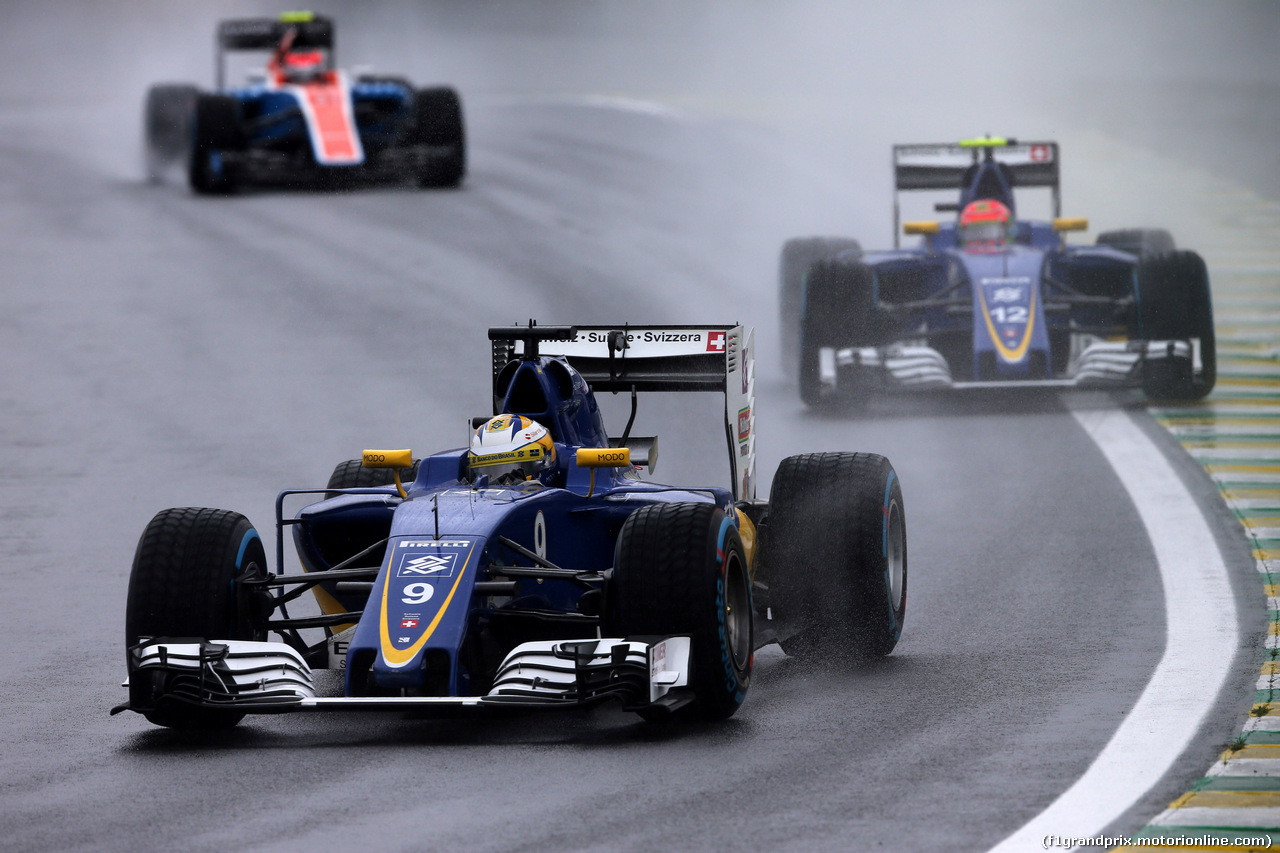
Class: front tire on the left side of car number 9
124,507,268,729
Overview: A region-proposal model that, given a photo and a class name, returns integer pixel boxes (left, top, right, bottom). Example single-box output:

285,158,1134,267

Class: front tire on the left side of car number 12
799,259,883,407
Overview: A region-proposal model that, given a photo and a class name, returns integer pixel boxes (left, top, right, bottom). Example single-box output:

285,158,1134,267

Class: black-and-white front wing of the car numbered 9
111,637,692,713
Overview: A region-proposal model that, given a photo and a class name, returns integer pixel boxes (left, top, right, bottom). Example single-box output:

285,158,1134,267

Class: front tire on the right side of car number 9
608,503,754,720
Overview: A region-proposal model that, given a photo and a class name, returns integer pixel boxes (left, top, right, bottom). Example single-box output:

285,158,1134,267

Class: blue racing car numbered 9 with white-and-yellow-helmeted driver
115,324,906,729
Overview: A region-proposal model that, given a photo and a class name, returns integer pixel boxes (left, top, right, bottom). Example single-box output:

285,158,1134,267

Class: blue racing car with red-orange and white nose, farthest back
143,13,466,193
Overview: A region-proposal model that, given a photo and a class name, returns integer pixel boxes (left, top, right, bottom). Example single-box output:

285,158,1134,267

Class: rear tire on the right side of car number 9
759,453,906,661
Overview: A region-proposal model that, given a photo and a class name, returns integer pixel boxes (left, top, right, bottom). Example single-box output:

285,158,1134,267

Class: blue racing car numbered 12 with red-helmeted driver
780,138,1216,406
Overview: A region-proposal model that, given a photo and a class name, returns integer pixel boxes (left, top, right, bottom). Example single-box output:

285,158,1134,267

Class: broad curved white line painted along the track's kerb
993,410,1239,853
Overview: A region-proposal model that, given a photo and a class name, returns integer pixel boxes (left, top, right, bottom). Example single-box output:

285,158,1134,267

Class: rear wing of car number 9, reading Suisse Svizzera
489,325,755,501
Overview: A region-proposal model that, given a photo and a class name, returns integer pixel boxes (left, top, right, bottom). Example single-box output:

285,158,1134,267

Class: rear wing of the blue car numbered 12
893,137,1062,248
